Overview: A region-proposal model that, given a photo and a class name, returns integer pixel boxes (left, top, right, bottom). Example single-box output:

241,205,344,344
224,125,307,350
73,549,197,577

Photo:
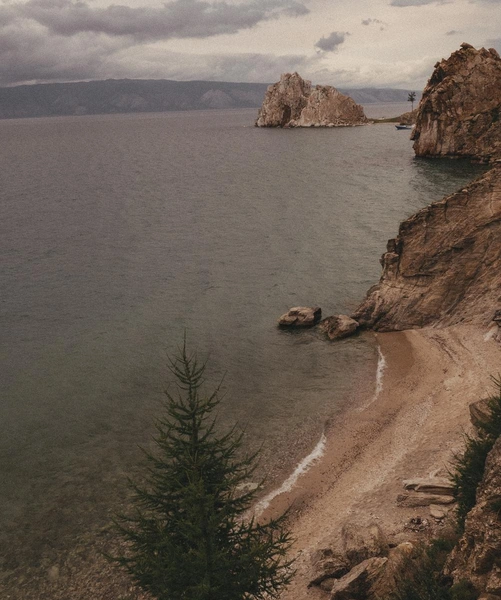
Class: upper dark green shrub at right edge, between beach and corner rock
451,378,501,532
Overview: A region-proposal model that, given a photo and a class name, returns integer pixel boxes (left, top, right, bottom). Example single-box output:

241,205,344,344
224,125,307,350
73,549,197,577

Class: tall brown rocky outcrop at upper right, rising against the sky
411,43,501,161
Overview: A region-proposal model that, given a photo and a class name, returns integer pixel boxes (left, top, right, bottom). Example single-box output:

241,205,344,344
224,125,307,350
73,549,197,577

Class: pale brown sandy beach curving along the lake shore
263,326,501,600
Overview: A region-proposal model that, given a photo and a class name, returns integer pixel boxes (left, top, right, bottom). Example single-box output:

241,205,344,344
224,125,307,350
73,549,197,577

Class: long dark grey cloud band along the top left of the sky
0,0,309,41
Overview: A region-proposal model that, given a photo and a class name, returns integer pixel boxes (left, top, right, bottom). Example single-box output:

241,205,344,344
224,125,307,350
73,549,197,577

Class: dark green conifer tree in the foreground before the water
114,346,292,600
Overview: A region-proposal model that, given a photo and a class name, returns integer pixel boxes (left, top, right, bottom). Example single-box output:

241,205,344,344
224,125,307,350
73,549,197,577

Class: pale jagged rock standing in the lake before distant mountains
256,73,368,127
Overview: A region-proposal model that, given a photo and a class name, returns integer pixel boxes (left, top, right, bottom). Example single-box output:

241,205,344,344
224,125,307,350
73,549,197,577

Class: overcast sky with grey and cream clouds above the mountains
0,0,501,89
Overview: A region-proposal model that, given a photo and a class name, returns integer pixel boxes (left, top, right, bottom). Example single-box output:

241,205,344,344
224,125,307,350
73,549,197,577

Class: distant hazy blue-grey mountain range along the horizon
0,79,418,119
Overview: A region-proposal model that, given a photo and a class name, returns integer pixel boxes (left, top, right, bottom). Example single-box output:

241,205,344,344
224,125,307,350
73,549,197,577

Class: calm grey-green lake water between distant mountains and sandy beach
0,110,479,577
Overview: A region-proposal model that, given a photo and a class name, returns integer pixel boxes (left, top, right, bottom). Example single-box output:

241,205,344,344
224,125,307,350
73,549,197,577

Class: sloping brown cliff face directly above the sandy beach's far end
352,164,501,331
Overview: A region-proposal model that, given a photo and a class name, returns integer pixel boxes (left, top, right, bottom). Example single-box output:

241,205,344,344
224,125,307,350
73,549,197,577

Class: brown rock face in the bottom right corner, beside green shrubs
446,438,501,598
